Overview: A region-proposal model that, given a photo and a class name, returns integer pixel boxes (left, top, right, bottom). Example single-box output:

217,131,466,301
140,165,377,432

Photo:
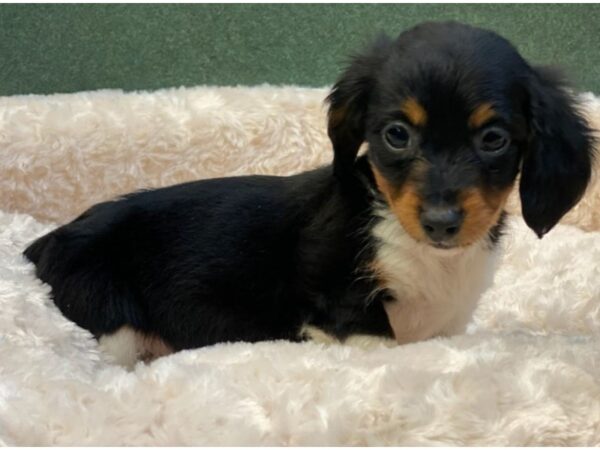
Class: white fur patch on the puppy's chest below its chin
373,209,497,343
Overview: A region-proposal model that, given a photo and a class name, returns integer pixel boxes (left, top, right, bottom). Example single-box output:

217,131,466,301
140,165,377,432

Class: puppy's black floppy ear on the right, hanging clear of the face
520,68,593,238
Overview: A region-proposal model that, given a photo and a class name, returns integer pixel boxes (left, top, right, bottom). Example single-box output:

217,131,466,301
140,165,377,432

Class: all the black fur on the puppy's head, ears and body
25,23,591,350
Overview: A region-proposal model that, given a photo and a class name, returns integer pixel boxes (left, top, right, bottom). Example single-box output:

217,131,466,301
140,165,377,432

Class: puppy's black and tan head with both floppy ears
328,23,592,248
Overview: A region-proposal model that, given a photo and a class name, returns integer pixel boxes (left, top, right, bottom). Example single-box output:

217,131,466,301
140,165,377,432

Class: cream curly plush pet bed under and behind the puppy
0,87,600,446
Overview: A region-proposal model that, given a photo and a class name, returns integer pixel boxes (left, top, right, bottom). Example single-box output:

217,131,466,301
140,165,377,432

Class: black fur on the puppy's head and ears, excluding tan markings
329,22,593,237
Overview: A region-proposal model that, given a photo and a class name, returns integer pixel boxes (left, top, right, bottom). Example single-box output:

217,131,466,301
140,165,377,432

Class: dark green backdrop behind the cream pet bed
0,4,600,95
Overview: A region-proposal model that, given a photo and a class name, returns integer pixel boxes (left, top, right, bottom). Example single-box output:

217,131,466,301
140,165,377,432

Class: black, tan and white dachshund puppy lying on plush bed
25,23,592,364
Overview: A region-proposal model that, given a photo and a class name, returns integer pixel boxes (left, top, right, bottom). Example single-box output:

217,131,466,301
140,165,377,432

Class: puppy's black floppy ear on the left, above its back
327,35,392,178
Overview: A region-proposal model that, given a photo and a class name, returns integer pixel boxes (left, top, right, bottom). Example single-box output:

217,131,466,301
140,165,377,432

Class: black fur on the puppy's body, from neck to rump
25,160,390,349
